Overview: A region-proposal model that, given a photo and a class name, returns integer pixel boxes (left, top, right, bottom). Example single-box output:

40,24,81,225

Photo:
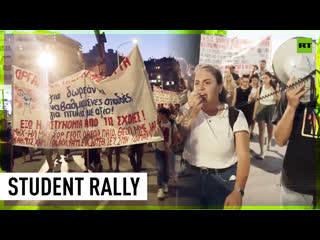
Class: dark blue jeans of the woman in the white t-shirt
176,164,237,208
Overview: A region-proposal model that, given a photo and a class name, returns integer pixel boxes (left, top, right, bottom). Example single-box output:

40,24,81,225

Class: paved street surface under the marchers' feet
5,125,286,206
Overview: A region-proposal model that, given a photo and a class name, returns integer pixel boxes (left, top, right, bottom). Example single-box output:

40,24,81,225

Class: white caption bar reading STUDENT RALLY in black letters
0,173,148,200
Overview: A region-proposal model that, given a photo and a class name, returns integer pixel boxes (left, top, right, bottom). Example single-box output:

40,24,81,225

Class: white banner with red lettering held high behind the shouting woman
199,34,271,76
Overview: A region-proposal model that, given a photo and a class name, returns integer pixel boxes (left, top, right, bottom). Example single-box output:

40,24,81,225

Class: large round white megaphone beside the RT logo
272,37,317,103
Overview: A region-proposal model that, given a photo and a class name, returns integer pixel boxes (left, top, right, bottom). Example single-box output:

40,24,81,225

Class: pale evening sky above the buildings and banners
66,30,320,64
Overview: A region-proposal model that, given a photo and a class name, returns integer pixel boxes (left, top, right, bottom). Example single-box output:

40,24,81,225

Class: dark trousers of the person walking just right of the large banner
156,149,169,188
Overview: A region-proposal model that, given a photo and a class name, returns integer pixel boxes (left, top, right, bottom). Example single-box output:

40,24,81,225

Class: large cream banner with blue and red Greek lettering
12,46,163,149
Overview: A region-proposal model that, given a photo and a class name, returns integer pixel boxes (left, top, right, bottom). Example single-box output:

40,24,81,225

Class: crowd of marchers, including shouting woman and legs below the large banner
1,60,318,206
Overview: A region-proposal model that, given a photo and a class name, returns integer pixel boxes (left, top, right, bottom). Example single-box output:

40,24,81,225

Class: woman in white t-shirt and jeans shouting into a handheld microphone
177,65,250,208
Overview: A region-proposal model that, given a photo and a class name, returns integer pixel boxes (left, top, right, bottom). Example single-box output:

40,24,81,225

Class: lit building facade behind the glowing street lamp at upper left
3,33,85,118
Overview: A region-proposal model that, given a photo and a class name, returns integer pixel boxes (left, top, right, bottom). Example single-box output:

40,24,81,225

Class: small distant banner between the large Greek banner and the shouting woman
153,86,187,108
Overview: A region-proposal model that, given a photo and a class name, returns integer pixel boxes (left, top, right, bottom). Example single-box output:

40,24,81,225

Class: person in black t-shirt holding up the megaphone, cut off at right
273,77,319,206
